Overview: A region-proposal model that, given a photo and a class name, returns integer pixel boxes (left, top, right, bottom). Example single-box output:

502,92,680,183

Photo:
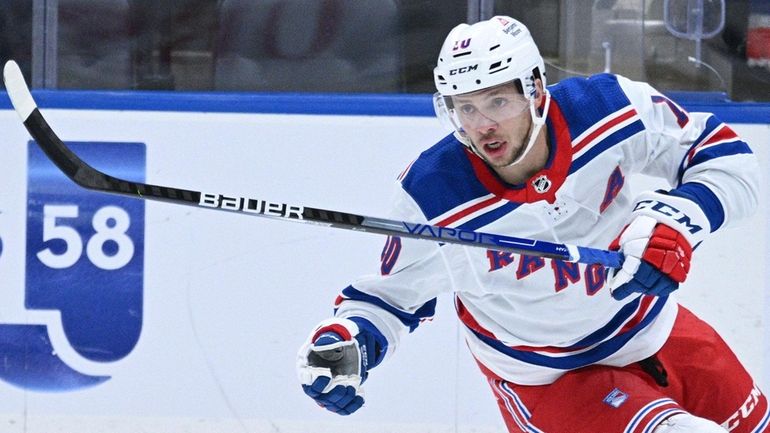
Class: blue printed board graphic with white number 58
0,142,146,390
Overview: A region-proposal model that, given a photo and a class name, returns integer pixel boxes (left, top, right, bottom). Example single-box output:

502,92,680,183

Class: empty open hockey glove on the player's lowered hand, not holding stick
297,318,384,415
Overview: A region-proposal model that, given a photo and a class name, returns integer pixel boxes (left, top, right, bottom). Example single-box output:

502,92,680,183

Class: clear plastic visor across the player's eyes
435,82,529,135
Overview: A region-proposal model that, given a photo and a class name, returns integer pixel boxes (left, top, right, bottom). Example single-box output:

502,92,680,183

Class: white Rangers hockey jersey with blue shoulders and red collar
336,74,759,385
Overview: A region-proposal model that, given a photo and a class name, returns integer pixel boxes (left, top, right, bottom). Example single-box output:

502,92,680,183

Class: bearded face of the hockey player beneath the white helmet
452,84,532,167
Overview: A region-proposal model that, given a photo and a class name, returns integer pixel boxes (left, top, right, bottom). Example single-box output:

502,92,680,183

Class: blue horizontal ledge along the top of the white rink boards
0,90,770,124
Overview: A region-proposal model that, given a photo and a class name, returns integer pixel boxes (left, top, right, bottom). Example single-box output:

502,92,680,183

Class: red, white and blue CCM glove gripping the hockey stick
609,192,710,299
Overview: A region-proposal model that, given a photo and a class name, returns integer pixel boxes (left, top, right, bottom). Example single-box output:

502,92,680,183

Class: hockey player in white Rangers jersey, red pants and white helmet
298,16,770,433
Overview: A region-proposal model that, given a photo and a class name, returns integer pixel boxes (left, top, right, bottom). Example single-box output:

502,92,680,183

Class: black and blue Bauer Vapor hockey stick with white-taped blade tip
3,61,623,268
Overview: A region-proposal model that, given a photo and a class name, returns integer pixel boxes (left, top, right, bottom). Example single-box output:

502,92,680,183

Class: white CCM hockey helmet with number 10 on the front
433,16,546,98
